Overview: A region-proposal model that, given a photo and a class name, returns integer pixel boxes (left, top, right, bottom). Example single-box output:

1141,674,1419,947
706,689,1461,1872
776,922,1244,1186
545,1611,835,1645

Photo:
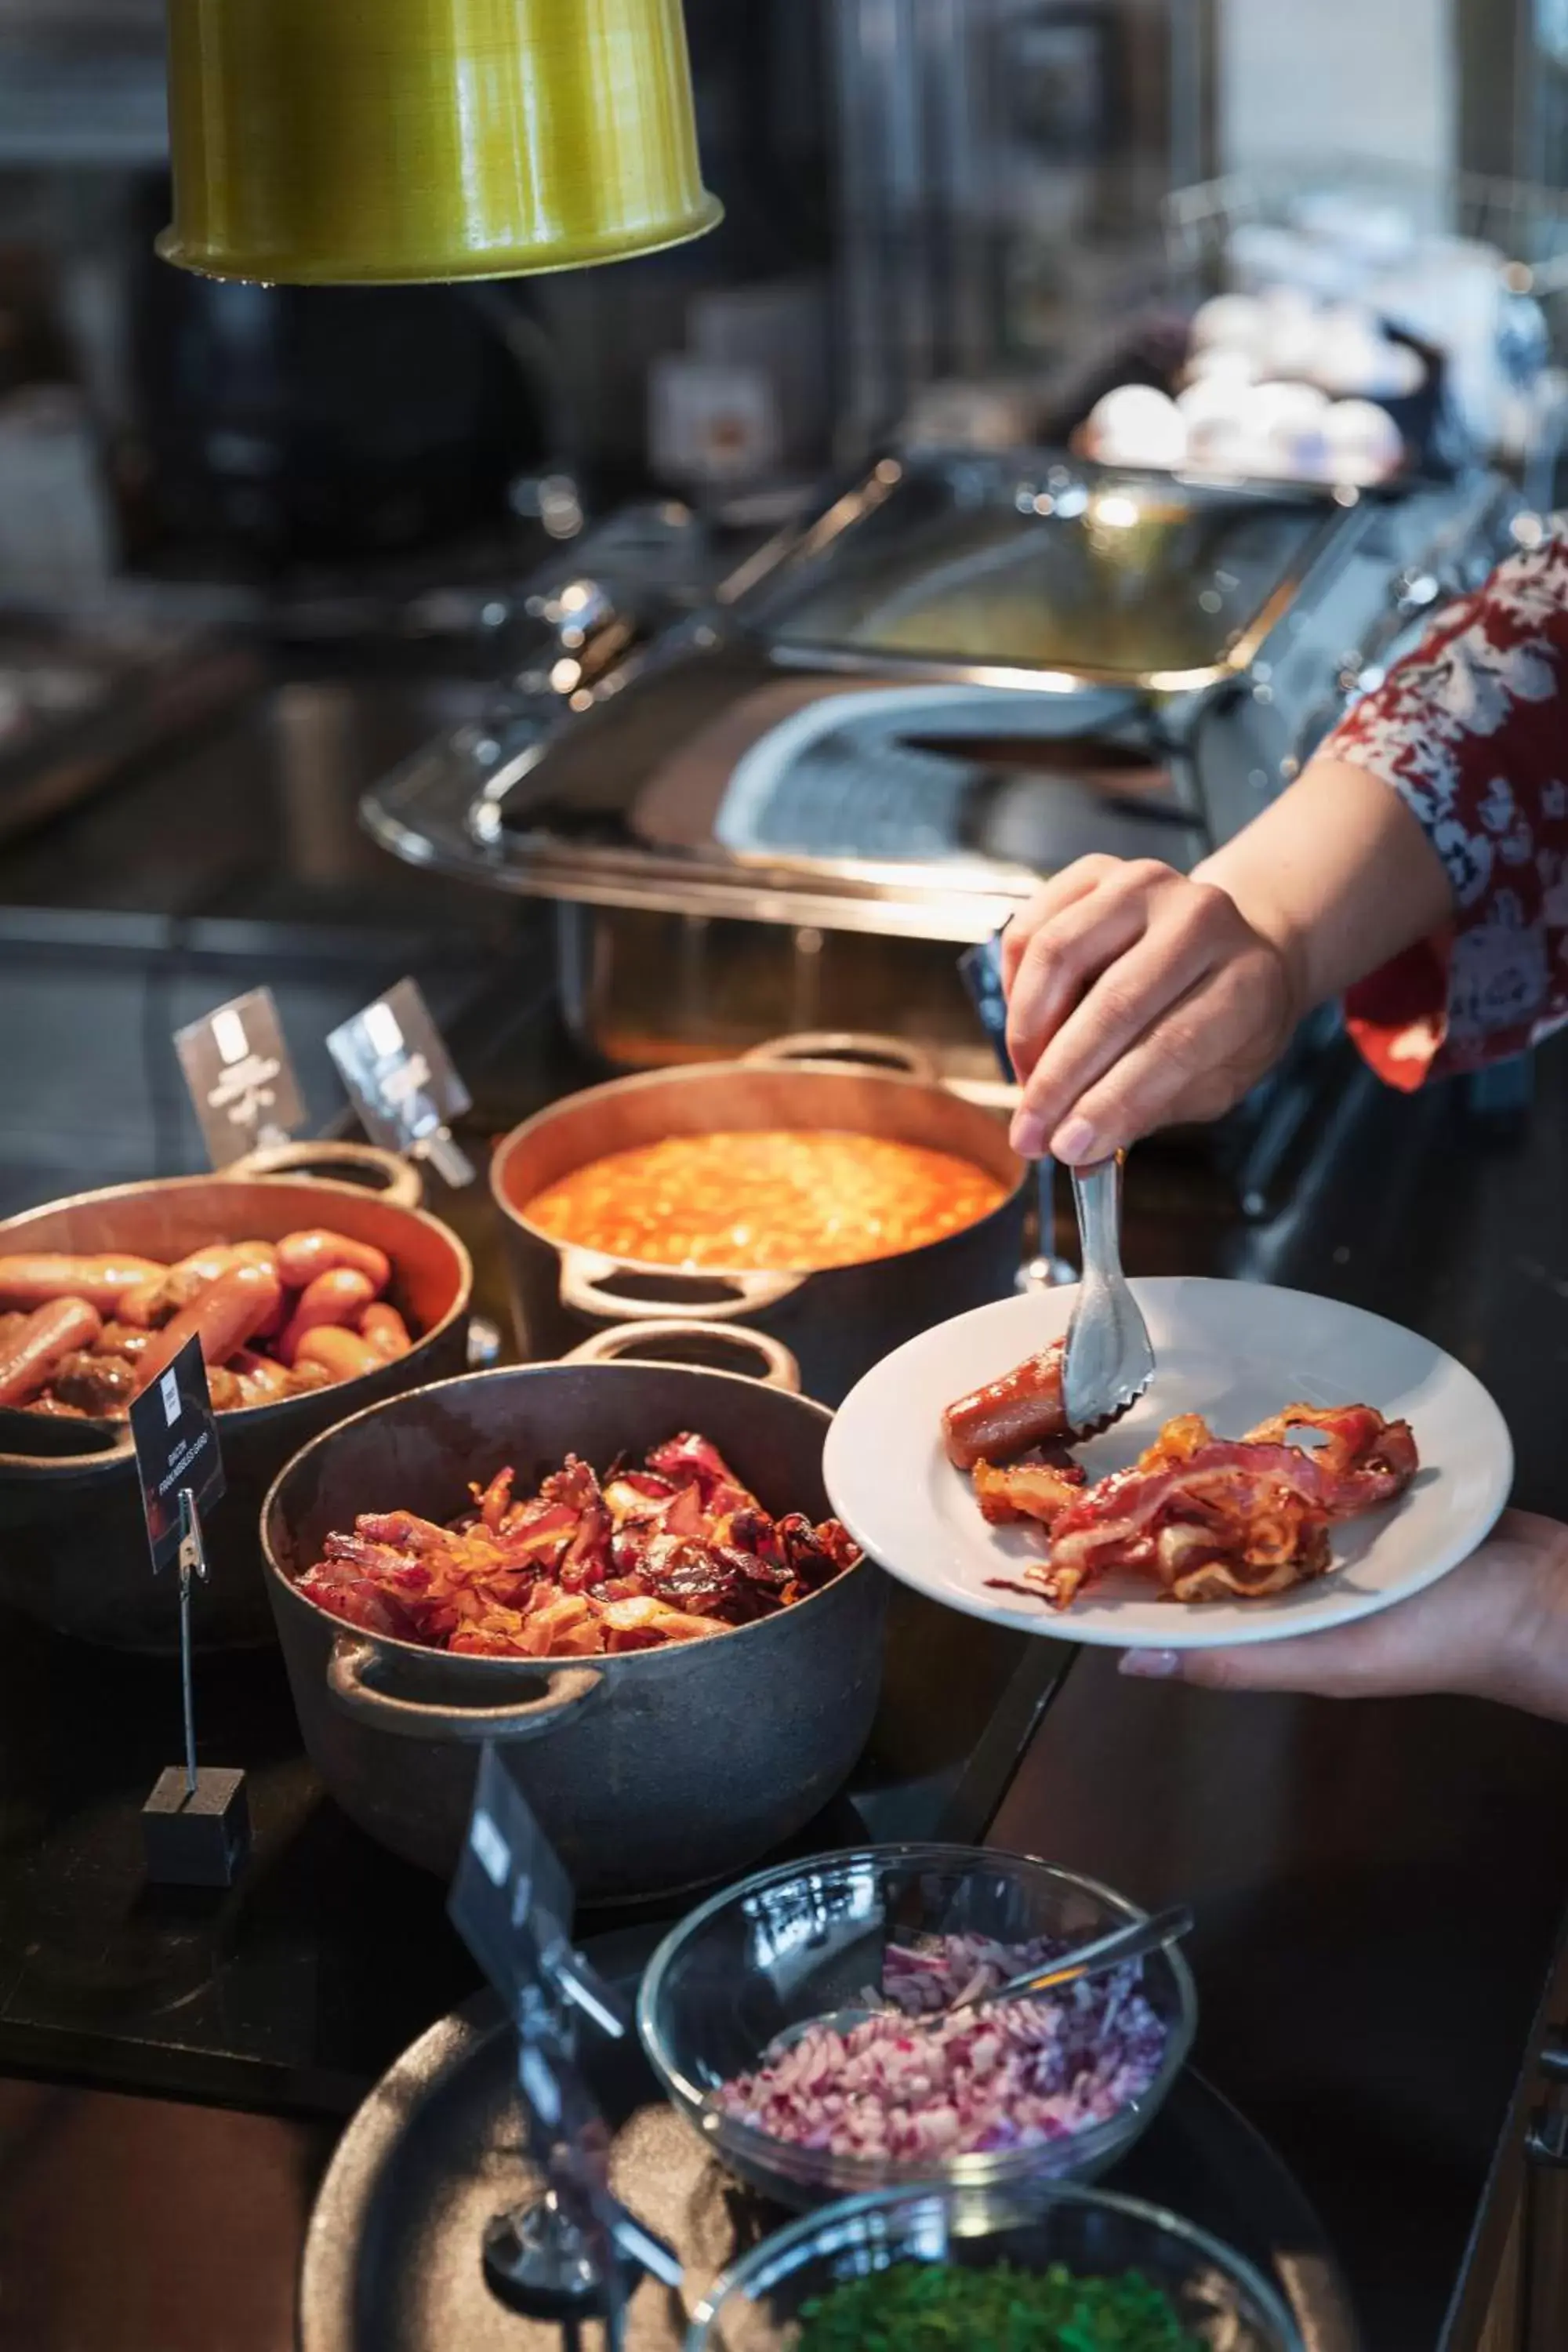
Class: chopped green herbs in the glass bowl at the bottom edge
799,2263,1201,2352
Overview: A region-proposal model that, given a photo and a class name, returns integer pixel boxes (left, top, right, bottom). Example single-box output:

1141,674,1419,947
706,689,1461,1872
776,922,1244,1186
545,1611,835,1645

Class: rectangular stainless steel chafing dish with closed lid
365,452,1516,1089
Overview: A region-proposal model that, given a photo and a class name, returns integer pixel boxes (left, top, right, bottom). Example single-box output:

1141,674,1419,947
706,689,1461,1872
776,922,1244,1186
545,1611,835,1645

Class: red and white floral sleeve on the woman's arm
1323,539,1568,1091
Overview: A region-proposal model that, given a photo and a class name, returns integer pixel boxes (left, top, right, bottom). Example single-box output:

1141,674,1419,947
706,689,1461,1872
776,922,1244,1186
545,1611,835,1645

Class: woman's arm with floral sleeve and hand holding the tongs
1006,541,1568,1162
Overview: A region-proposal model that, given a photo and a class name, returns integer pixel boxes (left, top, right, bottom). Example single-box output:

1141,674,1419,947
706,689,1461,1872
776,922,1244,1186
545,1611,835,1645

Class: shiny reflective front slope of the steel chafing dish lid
481,647,1199,898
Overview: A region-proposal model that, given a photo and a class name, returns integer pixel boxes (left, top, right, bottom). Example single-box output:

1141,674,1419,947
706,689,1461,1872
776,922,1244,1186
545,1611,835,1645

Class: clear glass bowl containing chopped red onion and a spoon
637,1846,1196,2209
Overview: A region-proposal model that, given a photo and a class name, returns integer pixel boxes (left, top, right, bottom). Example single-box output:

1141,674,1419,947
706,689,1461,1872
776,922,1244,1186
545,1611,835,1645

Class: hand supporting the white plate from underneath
1121,1510,1568,1722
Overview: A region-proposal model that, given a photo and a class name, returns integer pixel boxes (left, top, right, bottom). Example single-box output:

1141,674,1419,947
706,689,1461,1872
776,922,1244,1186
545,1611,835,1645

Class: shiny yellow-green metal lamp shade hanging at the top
158,0,722,285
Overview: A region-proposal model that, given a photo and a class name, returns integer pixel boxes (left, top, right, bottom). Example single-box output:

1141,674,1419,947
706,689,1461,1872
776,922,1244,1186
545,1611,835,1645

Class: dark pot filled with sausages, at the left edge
0,1176,473,1651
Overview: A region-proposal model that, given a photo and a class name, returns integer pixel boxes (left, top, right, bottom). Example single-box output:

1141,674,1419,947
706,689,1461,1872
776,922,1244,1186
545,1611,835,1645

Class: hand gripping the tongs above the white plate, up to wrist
1001,856,1307,1167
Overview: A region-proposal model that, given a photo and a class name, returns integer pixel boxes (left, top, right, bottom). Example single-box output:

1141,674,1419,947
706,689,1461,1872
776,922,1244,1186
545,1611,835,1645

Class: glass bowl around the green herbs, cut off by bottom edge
687,2180,1302,2352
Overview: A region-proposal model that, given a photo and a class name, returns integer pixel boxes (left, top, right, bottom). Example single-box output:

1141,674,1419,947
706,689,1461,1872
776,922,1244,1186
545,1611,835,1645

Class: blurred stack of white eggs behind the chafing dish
1083,289,1427,487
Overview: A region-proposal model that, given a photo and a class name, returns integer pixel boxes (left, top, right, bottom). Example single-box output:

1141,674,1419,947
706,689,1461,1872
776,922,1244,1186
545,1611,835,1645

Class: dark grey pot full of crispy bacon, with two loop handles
263,1329,886,1900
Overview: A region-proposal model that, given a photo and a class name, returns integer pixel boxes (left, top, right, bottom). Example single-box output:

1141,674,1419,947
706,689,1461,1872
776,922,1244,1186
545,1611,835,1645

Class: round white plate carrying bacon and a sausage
822,1277,1514,1649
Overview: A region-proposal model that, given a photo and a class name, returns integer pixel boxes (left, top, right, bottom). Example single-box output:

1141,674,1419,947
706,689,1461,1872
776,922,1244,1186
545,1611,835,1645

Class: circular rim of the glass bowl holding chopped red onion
637,1839,1196,2201
